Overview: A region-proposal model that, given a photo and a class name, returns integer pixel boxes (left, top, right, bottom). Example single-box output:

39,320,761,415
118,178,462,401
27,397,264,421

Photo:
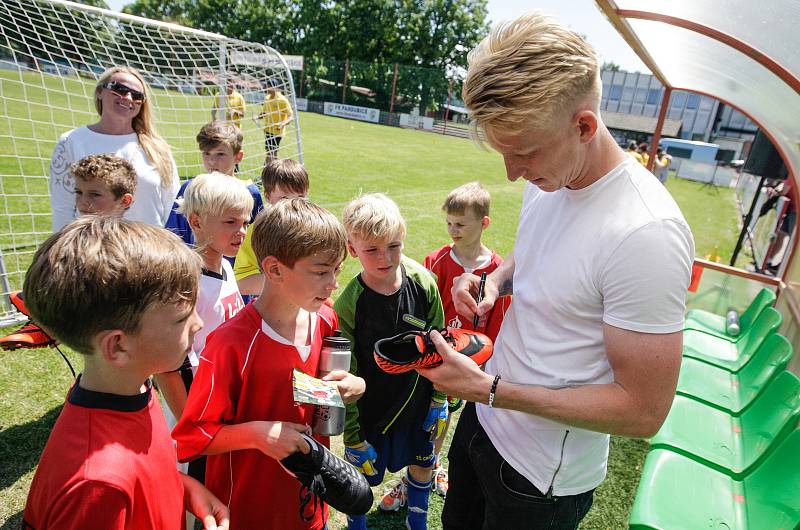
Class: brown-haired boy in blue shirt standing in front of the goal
166,121,264,245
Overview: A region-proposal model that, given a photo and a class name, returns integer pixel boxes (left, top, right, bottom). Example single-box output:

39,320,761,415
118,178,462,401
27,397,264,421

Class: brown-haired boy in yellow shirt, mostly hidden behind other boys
233,158,309,295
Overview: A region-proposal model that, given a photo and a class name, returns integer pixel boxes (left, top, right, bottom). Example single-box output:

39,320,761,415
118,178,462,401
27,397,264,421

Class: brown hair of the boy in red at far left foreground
23,215,201,355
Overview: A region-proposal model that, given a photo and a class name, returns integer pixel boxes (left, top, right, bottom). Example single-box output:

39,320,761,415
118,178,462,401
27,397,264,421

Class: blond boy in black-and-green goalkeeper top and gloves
334,193,447,530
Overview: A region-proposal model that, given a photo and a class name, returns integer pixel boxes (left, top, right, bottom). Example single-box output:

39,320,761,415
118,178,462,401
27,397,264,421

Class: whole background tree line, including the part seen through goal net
0,0,489,112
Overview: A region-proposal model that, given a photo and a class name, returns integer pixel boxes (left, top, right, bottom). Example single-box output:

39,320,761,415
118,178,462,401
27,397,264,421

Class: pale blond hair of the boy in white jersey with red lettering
176,171,253,218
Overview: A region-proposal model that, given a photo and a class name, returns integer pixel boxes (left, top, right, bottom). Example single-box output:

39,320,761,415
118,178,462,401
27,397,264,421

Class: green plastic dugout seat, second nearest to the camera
650,372,800,478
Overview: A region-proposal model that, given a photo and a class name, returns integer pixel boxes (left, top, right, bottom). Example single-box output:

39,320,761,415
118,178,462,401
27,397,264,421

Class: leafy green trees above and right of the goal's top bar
120,0,489,112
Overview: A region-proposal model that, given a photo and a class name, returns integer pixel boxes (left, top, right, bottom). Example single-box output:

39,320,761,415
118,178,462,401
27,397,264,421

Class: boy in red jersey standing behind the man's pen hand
423,182,511,496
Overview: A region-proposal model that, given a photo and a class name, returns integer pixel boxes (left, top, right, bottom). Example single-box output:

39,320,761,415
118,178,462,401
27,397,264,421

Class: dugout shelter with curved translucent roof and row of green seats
596,0,800,529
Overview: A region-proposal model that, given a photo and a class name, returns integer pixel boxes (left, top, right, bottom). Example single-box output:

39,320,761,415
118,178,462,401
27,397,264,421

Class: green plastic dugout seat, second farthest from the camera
683,307,783,372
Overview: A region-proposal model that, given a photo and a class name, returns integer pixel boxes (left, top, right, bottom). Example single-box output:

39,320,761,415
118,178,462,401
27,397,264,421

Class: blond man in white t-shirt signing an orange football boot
420,14,694,529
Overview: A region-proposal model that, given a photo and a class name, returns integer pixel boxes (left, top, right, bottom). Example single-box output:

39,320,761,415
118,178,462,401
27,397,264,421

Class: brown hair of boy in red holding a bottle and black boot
253,198,347,267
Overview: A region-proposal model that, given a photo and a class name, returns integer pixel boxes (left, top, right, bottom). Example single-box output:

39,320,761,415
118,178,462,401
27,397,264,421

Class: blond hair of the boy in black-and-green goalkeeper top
342,193,406,241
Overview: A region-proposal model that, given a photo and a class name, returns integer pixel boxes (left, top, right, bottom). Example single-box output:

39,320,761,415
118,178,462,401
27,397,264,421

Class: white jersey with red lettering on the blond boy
189,259,244,370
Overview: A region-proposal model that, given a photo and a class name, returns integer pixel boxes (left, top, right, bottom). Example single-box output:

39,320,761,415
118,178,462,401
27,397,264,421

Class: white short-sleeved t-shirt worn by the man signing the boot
477,159,694,496
